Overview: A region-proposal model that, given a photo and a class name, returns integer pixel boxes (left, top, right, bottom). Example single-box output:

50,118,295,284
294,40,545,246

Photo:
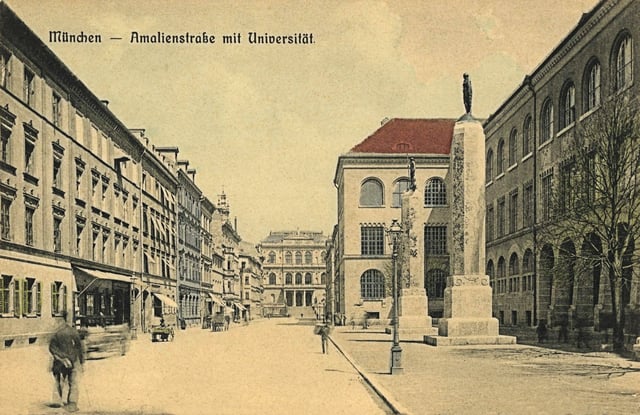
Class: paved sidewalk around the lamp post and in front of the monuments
332,327,640,415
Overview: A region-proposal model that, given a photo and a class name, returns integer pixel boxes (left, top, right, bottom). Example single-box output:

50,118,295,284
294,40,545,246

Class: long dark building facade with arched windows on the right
484,1,640,336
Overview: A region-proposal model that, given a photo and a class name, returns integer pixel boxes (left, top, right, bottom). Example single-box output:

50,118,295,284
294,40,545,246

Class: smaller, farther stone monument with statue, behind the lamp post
398,158,435,340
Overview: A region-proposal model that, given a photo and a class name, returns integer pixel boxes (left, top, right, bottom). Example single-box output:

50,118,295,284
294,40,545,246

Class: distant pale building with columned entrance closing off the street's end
260,231,327,318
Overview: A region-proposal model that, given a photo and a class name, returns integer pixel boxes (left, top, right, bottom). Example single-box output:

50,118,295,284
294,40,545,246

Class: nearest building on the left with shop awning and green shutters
0,2,145,347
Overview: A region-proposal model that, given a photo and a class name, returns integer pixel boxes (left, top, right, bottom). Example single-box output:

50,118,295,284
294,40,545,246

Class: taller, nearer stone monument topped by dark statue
424,74,516,346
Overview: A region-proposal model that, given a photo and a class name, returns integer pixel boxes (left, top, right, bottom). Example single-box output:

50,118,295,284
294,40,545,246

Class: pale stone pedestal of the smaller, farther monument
398,287,436,340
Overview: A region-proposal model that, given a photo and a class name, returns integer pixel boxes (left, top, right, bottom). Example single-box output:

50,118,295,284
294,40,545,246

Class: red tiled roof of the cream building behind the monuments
350,118,456,154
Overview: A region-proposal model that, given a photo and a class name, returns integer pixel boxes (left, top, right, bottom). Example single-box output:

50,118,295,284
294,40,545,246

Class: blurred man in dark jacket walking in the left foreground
49,313,84,412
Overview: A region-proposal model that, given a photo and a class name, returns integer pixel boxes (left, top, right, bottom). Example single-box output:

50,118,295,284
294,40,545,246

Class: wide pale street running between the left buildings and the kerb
0,319,385,415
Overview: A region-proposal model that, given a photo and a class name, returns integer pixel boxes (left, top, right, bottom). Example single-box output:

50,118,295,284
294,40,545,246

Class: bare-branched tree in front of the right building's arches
541,93,640,350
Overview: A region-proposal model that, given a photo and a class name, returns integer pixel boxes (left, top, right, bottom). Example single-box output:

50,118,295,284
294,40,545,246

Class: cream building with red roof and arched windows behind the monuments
331,119,455,324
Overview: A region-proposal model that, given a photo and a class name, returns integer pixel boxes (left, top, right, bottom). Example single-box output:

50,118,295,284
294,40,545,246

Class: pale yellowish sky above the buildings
6,0,597,242
